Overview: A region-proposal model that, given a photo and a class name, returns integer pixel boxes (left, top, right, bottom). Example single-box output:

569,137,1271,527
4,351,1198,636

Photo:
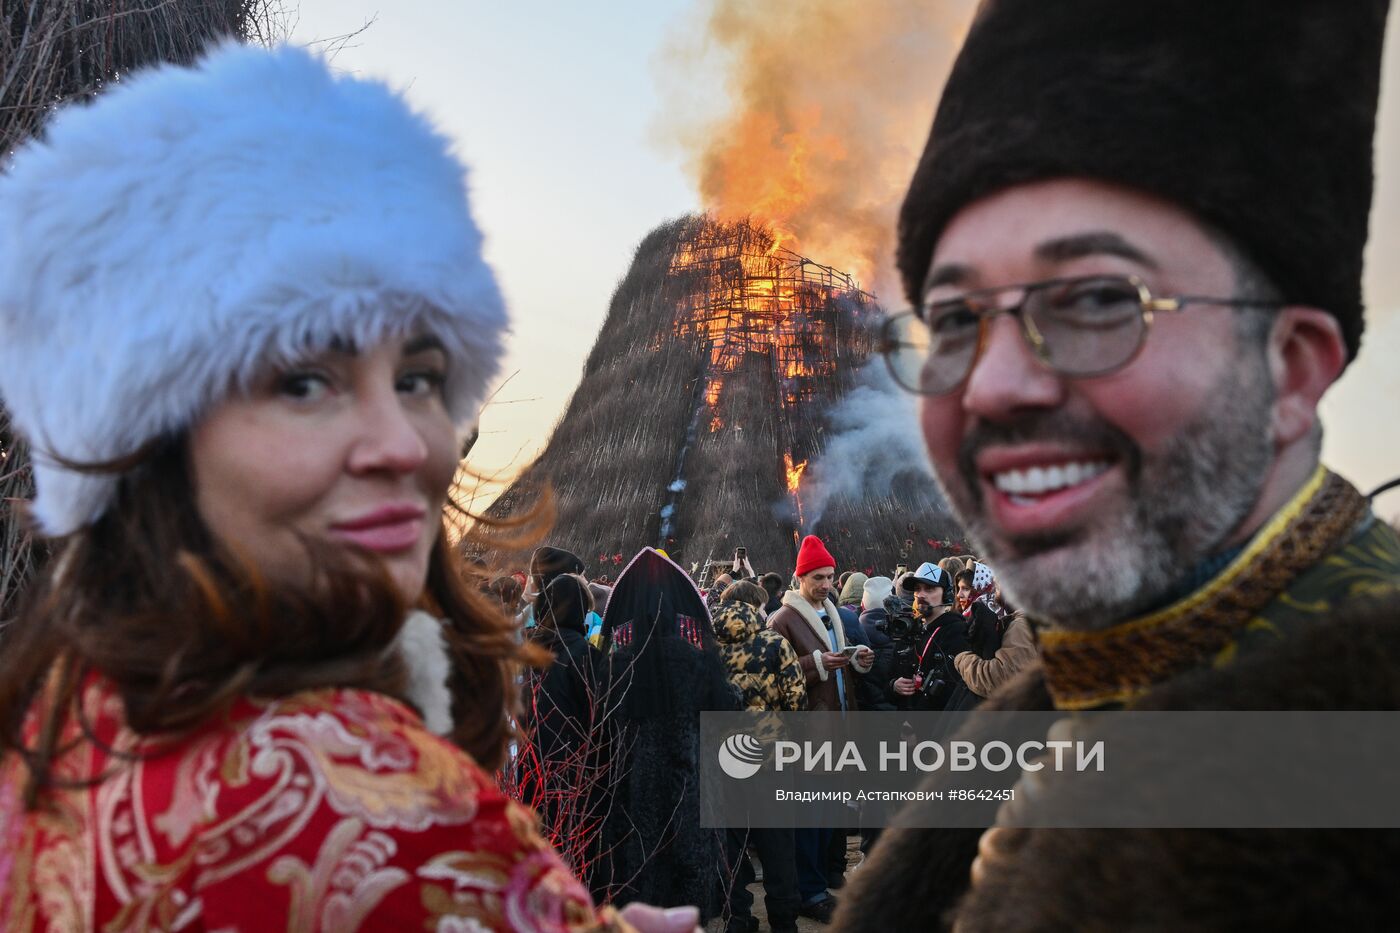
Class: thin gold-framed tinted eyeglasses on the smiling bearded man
879,276,1282,395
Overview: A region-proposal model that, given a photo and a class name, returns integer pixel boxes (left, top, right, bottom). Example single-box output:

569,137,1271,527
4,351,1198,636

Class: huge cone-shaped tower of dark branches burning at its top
490,216,956,574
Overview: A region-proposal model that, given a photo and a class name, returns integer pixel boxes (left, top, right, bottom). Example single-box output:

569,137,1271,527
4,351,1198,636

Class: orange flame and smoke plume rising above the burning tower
661,0,974,294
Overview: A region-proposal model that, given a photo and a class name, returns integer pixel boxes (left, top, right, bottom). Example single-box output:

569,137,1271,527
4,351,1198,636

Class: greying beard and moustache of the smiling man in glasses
939,353,1274,629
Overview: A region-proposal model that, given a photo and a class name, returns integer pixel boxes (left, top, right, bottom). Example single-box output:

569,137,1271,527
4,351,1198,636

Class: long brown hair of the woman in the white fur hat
0,438,547,806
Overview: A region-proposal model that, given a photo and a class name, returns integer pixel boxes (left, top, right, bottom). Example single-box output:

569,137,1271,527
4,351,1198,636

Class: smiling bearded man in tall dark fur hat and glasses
836,0,1400,930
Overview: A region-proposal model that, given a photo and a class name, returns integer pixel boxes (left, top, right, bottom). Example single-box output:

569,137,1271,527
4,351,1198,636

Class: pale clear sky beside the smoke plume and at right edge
291,0,1400,516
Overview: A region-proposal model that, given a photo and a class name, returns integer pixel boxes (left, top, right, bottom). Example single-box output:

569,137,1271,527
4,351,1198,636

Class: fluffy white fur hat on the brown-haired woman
0,45,507,535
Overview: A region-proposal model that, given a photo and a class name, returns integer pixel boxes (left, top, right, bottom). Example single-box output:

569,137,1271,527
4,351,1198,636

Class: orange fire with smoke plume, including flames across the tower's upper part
657,0,977,545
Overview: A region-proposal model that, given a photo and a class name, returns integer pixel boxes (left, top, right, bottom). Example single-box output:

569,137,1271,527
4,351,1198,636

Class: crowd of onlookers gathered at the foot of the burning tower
482,535,1035,932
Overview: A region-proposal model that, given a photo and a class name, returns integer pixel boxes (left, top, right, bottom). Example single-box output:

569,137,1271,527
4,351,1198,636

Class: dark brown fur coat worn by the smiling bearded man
833,597,1400,933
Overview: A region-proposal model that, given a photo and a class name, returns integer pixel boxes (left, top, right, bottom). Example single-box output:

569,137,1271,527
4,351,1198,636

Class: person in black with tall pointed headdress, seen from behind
603,548,739,922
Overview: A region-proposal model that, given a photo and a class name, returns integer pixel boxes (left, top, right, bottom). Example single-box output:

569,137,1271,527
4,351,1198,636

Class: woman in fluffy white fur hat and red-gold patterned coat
0,46,693,930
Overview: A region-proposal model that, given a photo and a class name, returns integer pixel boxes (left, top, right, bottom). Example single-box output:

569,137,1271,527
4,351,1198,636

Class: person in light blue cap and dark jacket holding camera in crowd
885,562,967,710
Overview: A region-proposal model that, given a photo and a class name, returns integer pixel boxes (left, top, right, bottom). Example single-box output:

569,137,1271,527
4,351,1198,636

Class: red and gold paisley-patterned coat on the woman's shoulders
0,678,627,933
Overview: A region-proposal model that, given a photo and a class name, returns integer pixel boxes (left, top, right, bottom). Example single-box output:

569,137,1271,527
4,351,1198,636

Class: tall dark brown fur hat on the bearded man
899,0,1389,357
